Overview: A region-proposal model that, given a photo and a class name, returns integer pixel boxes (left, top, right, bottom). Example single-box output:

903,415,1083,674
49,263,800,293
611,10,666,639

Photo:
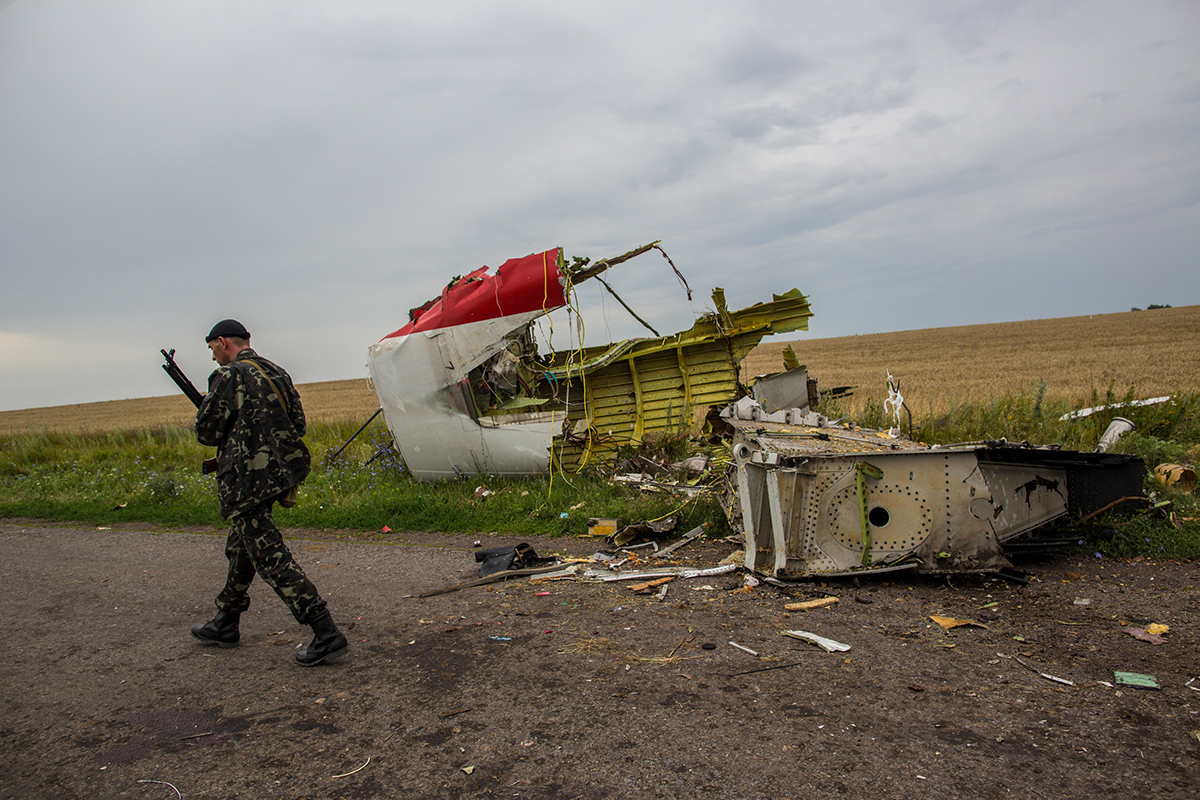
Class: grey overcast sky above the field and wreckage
0,0,1200,410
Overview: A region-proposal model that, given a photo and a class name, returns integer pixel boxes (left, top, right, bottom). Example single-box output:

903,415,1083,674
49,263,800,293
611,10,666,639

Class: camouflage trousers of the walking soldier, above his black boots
216,500,325,625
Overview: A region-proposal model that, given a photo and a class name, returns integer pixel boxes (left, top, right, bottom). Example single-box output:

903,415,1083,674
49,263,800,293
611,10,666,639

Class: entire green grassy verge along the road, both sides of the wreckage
0,389,1200,559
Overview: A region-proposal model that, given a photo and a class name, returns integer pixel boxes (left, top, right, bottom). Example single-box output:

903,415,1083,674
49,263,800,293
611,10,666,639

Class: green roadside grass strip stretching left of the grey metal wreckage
0,423,727,535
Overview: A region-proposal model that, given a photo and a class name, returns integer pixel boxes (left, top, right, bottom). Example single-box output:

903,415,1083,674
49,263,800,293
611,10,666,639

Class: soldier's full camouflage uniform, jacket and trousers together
196,348,325,625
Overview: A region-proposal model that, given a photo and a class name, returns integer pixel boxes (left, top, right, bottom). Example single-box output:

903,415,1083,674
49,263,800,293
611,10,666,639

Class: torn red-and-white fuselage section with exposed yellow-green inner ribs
368,242,811,480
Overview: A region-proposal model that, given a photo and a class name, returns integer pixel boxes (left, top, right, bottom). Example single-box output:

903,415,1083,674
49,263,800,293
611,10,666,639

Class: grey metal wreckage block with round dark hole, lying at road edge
730,415,1145,578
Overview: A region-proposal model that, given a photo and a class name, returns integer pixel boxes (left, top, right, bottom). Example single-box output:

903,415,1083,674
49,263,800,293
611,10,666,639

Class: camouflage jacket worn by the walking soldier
196,348,310,519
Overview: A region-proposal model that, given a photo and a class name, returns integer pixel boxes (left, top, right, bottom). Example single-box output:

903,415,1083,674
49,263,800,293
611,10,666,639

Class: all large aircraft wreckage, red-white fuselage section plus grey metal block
368,242,1145,578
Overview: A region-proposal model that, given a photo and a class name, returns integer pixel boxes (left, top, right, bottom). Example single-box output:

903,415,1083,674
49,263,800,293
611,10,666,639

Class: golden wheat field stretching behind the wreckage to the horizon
0,306,1200,434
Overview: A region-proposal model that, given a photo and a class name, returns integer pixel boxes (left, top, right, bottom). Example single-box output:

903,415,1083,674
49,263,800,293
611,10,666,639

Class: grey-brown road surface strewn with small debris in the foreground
0,522,1200,800
